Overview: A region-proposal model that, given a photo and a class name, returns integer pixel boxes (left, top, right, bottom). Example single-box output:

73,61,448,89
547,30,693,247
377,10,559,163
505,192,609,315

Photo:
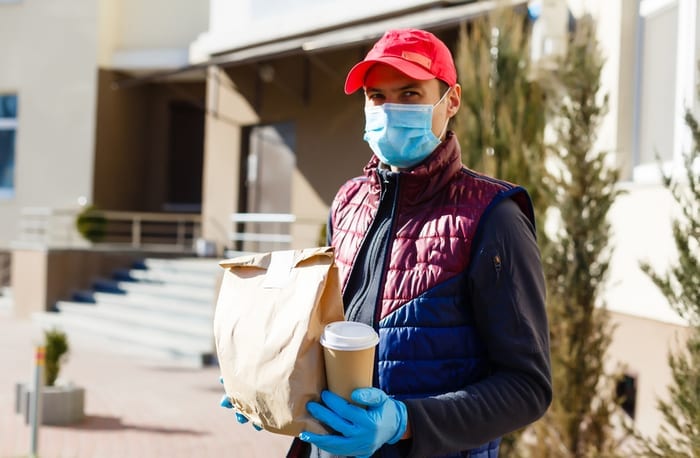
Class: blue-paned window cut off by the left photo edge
0,94,17,199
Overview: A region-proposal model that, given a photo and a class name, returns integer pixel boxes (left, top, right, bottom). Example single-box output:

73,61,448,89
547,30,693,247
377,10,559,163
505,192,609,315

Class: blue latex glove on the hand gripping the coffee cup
299,388,408,457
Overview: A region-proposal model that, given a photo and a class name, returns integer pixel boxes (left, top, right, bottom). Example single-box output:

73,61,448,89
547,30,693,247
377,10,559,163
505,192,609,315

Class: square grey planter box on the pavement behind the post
15,383,85,425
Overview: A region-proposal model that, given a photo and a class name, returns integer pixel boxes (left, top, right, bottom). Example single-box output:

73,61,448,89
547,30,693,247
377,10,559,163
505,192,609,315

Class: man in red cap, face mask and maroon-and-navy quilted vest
227,29,552,458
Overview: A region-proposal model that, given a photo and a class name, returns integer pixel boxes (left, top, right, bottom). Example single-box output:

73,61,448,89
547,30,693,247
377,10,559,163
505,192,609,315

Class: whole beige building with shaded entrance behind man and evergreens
0,0,700,444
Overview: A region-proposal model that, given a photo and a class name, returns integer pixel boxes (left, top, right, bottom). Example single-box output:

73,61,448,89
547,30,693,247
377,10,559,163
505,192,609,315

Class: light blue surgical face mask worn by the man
364,89,450,169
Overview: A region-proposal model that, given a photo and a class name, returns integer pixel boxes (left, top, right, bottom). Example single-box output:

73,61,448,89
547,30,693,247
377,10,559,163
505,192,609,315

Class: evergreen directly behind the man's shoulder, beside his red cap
454,8,549,241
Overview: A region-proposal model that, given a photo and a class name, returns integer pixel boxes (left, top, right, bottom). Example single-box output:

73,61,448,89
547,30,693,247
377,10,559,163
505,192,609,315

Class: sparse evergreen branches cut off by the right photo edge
642,106,700,457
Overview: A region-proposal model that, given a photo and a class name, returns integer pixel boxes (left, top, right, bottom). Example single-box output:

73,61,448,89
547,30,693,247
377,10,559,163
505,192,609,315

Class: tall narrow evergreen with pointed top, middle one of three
526,17,624,457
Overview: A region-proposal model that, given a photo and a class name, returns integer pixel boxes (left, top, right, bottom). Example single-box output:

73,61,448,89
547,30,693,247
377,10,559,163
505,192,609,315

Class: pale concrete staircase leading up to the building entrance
33,258,223,367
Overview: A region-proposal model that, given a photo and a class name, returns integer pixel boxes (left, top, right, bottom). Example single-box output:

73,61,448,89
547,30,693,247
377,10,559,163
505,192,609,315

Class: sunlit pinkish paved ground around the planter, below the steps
0,310,292,458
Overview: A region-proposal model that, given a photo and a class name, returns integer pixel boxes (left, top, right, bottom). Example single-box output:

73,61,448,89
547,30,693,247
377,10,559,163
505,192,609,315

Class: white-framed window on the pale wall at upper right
633,0,700,182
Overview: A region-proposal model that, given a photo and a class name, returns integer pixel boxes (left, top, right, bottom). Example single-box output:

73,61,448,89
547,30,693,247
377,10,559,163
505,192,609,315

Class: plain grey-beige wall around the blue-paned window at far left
0,0,98,245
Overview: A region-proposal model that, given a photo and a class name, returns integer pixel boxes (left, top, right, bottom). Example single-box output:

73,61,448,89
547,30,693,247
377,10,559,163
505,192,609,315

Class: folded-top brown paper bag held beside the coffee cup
214,247,344,436
